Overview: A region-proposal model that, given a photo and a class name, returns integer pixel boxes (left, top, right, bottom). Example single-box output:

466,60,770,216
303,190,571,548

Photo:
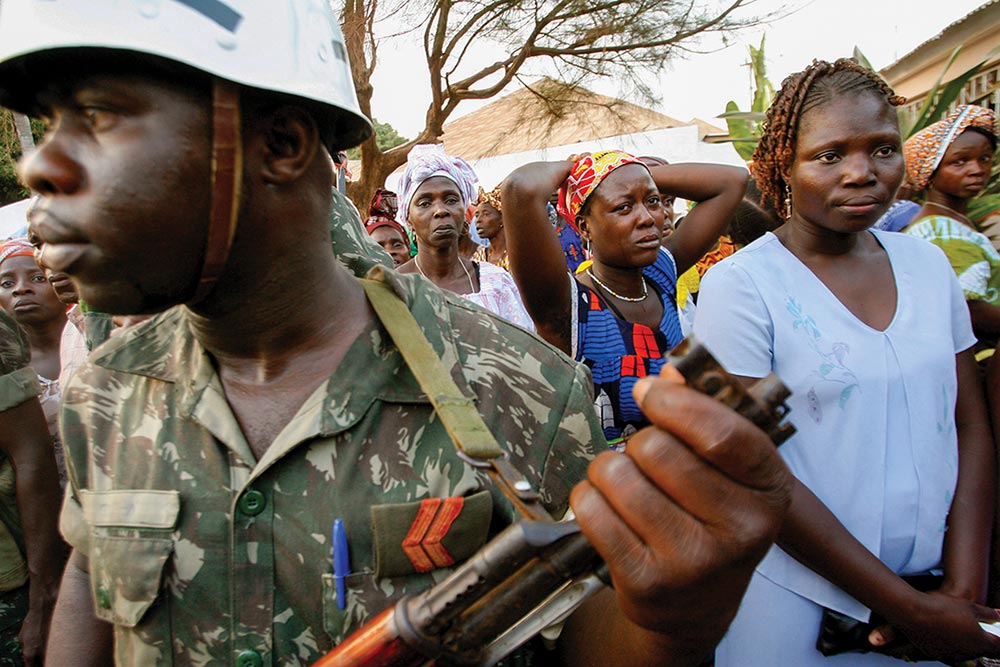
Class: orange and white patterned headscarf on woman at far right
903,104,998,192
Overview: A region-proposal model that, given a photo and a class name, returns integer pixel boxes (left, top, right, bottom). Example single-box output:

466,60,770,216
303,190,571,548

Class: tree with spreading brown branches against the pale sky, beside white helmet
340,0,770,208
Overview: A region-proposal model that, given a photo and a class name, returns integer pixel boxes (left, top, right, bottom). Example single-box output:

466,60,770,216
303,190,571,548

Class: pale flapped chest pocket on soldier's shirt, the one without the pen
80,490,180,628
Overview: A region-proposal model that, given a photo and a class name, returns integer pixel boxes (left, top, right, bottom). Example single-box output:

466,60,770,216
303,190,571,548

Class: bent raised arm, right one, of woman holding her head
649,164,749,275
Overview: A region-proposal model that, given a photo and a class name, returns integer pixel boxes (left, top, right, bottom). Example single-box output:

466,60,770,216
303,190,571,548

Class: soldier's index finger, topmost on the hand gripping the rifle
630,376,790,496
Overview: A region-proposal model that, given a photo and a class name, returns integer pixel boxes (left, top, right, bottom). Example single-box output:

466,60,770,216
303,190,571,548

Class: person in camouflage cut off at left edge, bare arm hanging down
0,310,66,666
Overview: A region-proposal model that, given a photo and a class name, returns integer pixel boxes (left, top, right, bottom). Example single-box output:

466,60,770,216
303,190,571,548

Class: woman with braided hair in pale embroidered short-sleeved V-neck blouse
695,60,1000,667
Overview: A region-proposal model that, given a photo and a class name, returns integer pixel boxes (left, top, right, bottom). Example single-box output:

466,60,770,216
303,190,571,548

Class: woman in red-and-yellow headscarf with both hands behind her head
501,151,747,448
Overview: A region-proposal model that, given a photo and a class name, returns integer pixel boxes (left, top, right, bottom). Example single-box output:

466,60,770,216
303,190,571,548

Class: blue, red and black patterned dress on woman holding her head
572,249,684,449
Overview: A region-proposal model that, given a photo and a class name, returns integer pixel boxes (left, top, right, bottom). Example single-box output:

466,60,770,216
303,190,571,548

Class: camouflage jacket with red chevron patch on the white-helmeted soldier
61,258,603,666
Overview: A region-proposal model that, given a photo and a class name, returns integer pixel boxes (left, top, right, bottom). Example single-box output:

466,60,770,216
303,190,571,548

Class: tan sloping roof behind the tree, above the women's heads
441,79,722,160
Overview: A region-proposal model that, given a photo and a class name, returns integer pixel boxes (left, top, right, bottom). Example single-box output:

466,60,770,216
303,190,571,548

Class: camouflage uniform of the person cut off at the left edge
0,310,41,666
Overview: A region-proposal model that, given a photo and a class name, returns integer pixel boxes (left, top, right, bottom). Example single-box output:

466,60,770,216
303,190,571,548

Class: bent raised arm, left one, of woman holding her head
500,160,573,354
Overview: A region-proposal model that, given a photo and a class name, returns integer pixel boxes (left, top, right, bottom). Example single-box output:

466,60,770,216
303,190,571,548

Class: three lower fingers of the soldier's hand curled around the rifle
570,420,787,595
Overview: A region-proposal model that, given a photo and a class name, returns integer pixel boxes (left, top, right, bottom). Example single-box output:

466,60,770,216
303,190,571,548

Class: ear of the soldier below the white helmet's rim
251,105,322,184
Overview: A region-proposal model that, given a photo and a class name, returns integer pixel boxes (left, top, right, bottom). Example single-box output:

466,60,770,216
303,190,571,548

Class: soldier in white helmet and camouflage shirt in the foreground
0,0,789,666
